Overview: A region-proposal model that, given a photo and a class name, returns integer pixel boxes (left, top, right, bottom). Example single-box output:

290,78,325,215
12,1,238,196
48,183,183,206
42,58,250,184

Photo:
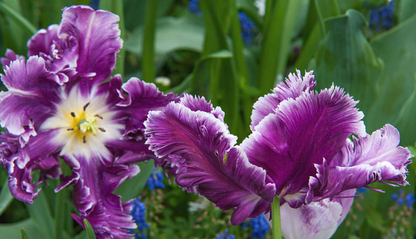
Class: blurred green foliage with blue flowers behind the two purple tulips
0,0,416,239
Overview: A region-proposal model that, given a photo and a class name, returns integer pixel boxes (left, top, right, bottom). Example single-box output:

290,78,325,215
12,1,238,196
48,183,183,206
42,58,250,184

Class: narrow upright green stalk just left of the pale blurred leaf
142,0,158,82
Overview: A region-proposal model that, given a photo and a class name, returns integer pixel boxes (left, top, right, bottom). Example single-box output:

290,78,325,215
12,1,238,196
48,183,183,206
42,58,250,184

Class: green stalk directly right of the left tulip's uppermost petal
99,0,126,76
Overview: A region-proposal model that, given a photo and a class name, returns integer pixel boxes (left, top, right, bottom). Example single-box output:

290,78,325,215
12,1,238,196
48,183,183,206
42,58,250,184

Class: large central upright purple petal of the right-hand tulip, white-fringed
241,87,365,207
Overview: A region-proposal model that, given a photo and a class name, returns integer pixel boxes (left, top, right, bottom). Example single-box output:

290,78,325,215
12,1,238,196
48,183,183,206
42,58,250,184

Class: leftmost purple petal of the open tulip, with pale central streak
0,56,60,144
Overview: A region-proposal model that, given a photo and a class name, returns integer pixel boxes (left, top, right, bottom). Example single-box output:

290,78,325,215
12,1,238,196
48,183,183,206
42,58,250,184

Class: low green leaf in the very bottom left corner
0,218,44,239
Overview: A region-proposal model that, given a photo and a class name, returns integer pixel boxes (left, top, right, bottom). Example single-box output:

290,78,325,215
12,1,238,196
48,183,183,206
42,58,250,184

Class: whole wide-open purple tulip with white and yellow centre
0,6,178,238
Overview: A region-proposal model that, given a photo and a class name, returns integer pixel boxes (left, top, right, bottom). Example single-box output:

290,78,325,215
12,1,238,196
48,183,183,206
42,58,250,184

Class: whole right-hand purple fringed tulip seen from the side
145,72,412,238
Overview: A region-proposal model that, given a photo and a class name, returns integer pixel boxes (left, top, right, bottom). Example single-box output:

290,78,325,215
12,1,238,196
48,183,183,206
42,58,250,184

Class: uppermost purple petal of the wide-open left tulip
58,6,123,83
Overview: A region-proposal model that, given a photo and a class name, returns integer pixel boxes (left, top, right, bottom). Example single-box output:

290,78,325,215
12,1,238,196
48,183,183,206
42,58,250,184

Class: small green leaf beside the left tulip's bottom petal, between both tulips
114,160,155,201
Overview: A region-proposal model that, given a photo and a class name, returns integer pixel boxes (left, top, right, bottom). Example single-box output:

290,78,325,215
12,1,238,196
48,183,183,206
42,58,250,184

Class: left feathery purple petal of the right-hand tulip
145,95,275,225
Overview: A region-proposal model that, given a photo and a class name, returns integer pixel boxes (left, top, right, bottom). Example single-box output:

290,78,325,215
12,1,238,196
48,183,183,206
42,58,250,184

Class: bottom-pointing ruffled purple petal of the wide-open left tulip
66,155,139,239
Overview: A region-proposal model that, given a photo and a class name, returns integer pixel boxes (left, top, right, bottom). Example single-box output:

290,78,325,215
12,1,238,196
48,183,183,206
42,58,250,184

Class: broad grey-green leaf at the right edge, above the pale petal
369,15,416,145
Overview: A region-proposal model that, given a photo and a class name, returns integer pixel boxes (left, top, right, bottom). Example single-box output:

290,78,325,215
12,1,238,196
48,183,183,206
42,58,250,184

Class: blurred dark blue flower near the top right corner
369,1,394,31
